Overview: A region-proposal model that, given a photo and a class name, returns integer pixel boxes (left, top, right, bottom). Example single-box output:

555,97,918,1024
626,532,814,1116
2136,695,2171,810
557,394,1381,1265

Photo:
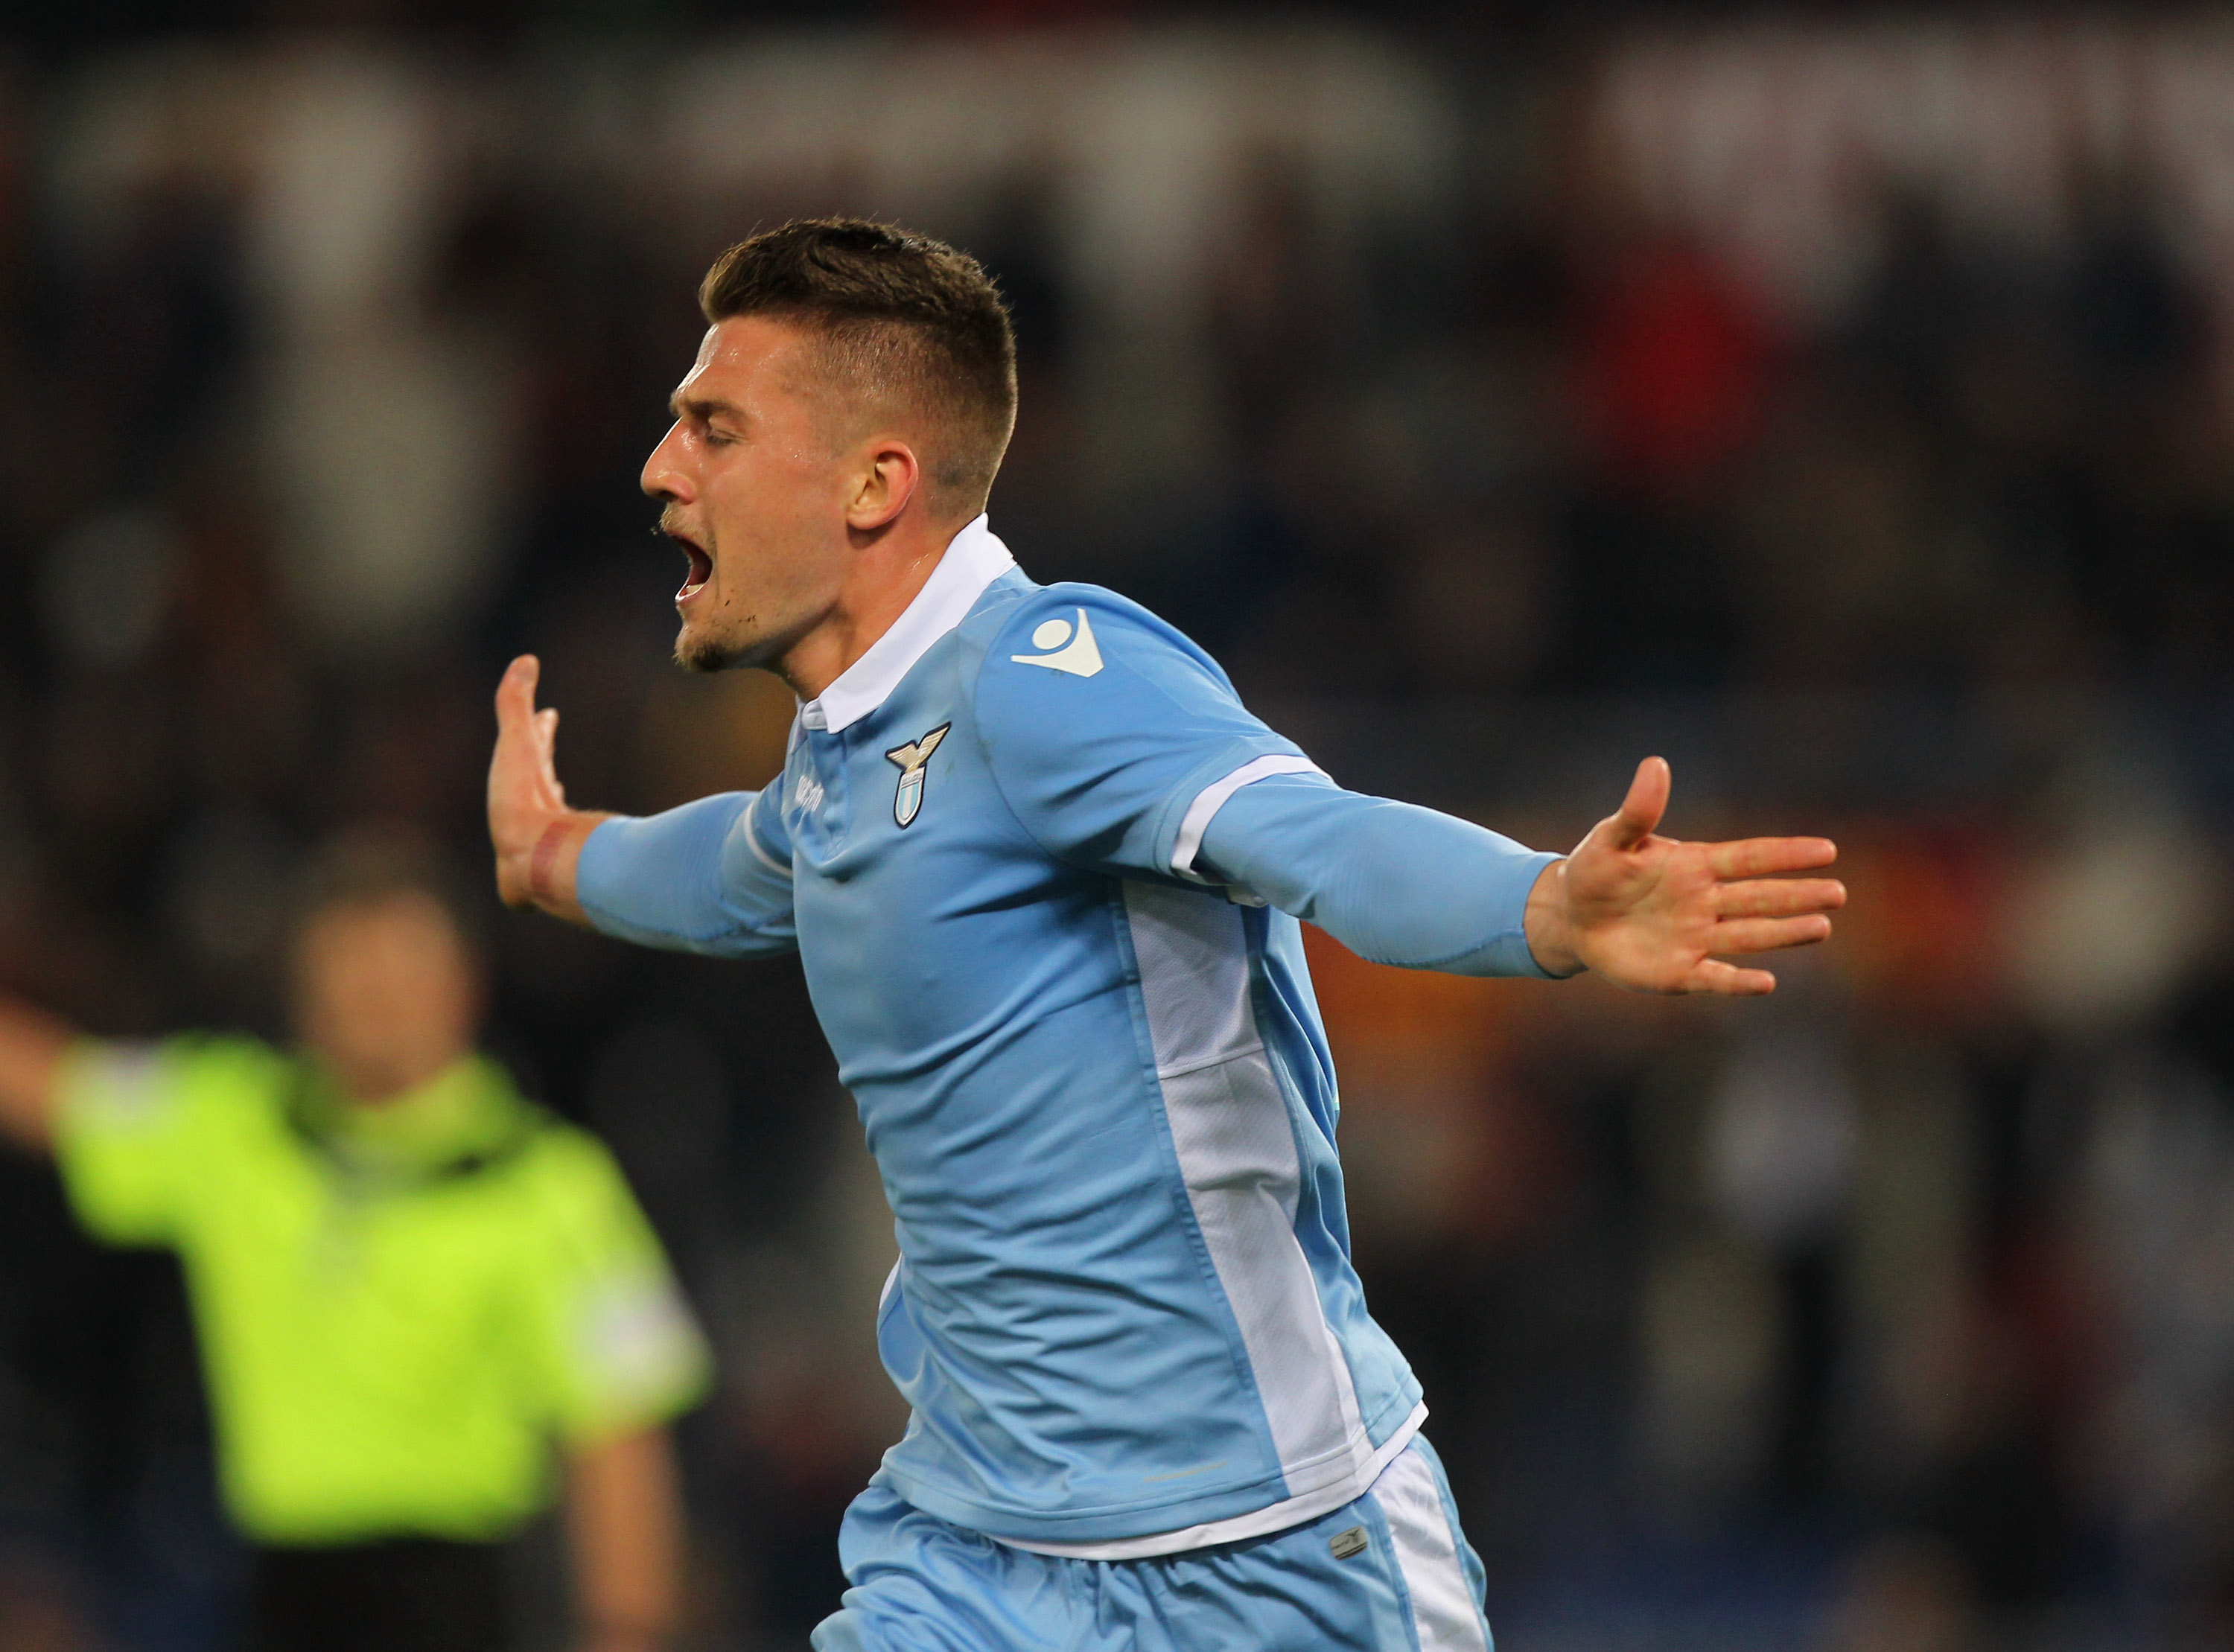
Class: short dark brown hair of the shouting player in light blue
699,219,1016,516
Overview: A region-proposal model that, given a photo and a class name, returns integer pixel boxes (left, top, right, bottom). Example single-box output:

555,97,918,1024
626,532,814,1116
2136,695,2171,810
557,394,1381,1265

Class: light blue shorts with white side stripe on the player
813,1440,1490,1652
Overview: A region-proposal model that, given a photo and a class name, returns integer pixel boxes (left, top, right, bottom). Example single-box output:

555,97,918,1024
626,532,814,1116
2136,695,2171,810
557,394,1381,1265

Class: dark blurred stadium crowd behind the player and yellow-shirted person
0,22,2234,1652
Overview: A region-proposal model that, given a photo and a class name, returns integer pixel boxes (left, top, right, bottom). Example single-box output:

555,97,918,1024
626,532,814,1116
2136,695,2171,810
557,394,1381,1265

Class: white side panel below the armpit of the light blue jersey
1126,881,1374,1498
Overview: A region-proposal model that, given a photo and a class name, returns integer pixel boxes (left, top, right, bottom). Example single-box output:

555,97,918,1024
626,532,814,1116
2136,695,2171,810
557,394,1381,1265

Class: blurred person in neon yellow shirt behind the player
0,839,708,1652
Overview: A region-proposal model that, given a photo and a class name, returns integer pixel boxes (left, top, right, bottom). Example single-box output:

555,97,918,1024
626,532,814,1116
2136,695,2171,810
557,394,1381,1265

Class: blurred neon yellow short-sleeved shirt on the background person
56,1038,710,1543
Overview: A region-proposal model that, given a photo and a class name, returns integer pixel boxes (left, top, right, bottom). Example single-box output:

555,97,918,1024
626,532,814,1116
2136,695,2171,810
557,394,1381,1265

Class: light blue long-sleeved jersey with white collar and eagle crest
579,518,1550,1558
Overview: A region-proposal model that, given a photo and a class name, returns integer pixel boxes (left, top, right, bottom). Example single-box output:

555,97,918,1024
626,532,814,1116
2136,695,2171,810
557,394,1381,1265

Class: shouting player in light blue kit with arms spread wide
489,221,1843,1652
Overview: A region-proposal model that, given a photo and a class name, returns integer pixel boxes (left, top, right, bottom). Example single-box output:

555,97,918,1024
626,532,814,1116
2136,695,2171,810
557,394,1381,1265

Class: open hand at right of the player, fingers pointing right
1526,757,1845,998
